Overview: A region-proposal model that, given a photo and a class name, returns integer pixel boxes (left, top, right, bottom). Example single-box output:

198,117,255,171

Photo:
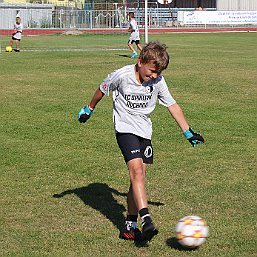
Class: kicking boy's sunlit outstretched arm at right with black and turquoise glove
168,103,204,147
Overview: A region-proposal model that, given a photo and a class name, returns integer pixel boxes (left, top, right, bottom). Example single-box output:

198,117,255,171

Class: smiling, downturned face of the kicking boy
137,59,161,83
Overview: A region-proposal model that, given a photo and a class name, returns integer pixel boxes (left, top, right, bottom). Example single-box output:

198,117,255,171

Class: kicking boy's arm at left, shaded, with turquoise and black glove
78,88,104,123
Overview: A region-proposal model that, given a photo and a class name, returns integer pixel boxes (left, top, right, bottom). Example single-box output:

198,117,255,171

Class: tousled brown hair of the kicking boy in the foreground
139,41,169,73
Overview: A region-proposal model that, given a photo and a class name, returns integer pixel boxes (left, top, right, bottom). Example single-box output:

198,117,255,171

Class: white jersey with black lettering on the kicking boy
100,65,176,139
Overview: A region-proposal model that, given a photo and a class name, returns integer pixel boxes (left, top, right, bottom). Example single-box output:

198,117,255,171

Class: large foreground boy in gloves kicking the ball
78,42,204,242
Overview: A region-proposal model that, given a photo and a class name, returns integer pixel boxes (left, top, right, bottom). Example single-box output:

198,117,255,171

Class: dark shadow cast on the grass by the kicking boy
53,183,164,230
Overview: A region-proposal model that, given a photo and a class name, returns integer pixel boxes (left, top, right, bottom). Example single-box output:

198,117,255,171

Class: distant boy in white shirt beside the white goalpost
128,12,142,59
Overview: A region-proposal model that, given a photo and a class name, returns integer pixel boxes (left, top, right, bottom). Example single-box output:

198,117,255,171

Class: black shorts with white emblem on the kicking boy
116,133,153,164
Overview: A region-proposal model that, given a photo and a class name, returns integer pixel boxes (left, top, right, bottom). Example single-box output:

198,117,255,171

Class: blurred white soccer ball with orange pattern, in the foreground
176,216,209,248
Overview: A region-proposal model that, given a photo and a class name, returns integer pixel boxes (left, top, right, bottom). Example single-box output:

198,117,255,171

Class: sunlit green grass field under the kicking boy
0,33,257,257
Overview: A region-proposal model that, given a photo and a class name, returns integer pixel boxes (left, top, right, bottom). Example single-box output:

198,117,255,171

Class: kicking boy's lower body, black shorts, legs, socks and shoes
116,133,158,242
